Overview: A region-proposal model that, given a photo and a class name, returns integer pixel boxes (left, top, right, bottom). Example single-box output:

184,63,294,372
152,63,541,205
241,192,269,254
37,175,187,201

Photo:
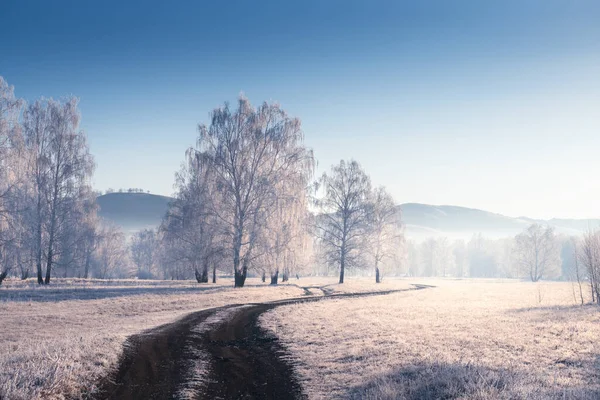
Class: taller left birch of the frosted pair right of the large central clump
316,160,371,283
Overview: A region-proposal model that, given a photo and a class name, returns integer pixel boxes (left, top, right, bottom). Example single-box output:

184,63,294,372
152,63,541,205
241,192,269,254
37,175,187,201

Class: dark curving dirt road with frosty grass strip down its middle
95,285,430,400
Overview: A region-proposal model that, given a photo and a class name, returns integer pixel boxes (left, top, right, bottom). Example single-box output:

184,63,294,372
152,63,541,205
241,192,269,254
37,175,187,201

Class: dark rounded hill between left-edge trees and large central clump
96,193,172,232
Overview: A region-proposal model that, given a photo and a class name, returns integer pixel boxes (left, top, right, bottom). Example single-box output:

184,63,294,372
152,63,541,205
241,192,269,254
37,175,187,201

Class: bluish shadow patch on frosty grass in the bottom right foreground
345,363,600,400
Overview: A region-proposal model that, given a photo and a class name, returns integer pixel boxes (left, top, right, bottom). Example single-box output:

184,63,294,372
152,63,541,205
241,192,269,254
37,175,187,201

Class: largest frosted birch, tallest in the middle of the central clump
196,97,314,287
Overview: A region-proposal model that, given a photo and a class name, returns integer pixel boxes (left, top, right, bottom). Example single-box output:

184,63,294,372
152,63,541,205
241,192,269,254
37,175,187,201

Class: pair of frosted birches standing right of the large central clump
315,160,403,283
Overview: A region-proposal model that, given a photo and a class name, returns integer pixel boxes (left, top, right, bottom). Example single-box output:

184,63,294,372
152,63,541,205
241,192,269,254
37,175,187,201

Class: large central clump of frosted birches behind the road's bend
160,97,315,287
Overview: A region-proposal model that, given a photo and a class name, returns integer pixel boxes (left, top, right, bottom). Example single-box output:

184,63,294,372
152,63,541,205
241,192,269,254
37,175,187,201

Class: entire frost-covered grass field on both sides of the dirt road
0,277,600,399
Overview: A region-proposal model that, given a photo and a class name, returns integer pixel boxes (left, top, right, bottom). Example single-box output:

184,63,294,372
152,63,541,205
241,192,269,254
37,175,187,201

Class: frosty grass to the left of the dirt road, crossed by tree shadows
0,279,304,400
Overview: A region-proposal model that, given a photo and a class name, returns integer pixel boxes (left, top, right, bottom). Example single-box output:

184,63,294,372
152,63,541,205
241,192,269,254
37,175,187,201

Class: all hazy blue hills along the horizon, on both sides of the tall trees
98,193,600,240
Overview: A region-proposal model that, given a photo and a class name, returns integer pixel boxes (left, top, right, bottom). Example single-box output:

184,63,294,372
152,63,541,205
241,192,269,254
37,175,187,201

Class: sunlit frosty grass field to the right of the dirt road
261,280,600,399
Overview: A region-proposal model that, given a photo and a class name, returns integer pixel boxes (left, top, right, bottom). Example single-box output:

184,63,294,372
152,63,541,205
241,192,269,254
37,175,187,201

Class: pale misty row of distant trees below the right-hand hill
400,224,600,303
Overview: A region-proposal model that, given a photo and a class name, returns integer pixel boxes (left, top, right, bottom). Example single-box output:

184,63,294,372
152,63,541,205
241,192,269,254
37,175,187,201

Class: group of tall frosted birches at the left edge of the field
0,77,136,284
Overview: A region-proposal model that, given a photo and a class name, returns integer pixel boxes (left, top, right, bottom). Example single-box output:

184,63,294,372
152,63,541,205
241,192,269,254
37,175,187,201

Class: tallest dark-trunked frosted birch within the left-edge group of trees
24,98,94,284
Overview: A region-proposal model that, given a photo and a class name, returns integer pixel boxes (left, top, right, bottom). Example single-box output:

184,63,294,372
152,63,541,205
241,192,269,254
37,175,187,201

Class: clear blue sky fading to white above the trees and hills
0,0,600,218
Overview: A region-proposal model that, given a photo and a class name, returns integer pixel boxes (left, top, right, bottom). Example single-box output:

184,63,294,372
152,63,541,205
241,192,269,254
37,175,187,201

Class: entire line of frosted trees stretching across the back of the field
0,77,600,302
